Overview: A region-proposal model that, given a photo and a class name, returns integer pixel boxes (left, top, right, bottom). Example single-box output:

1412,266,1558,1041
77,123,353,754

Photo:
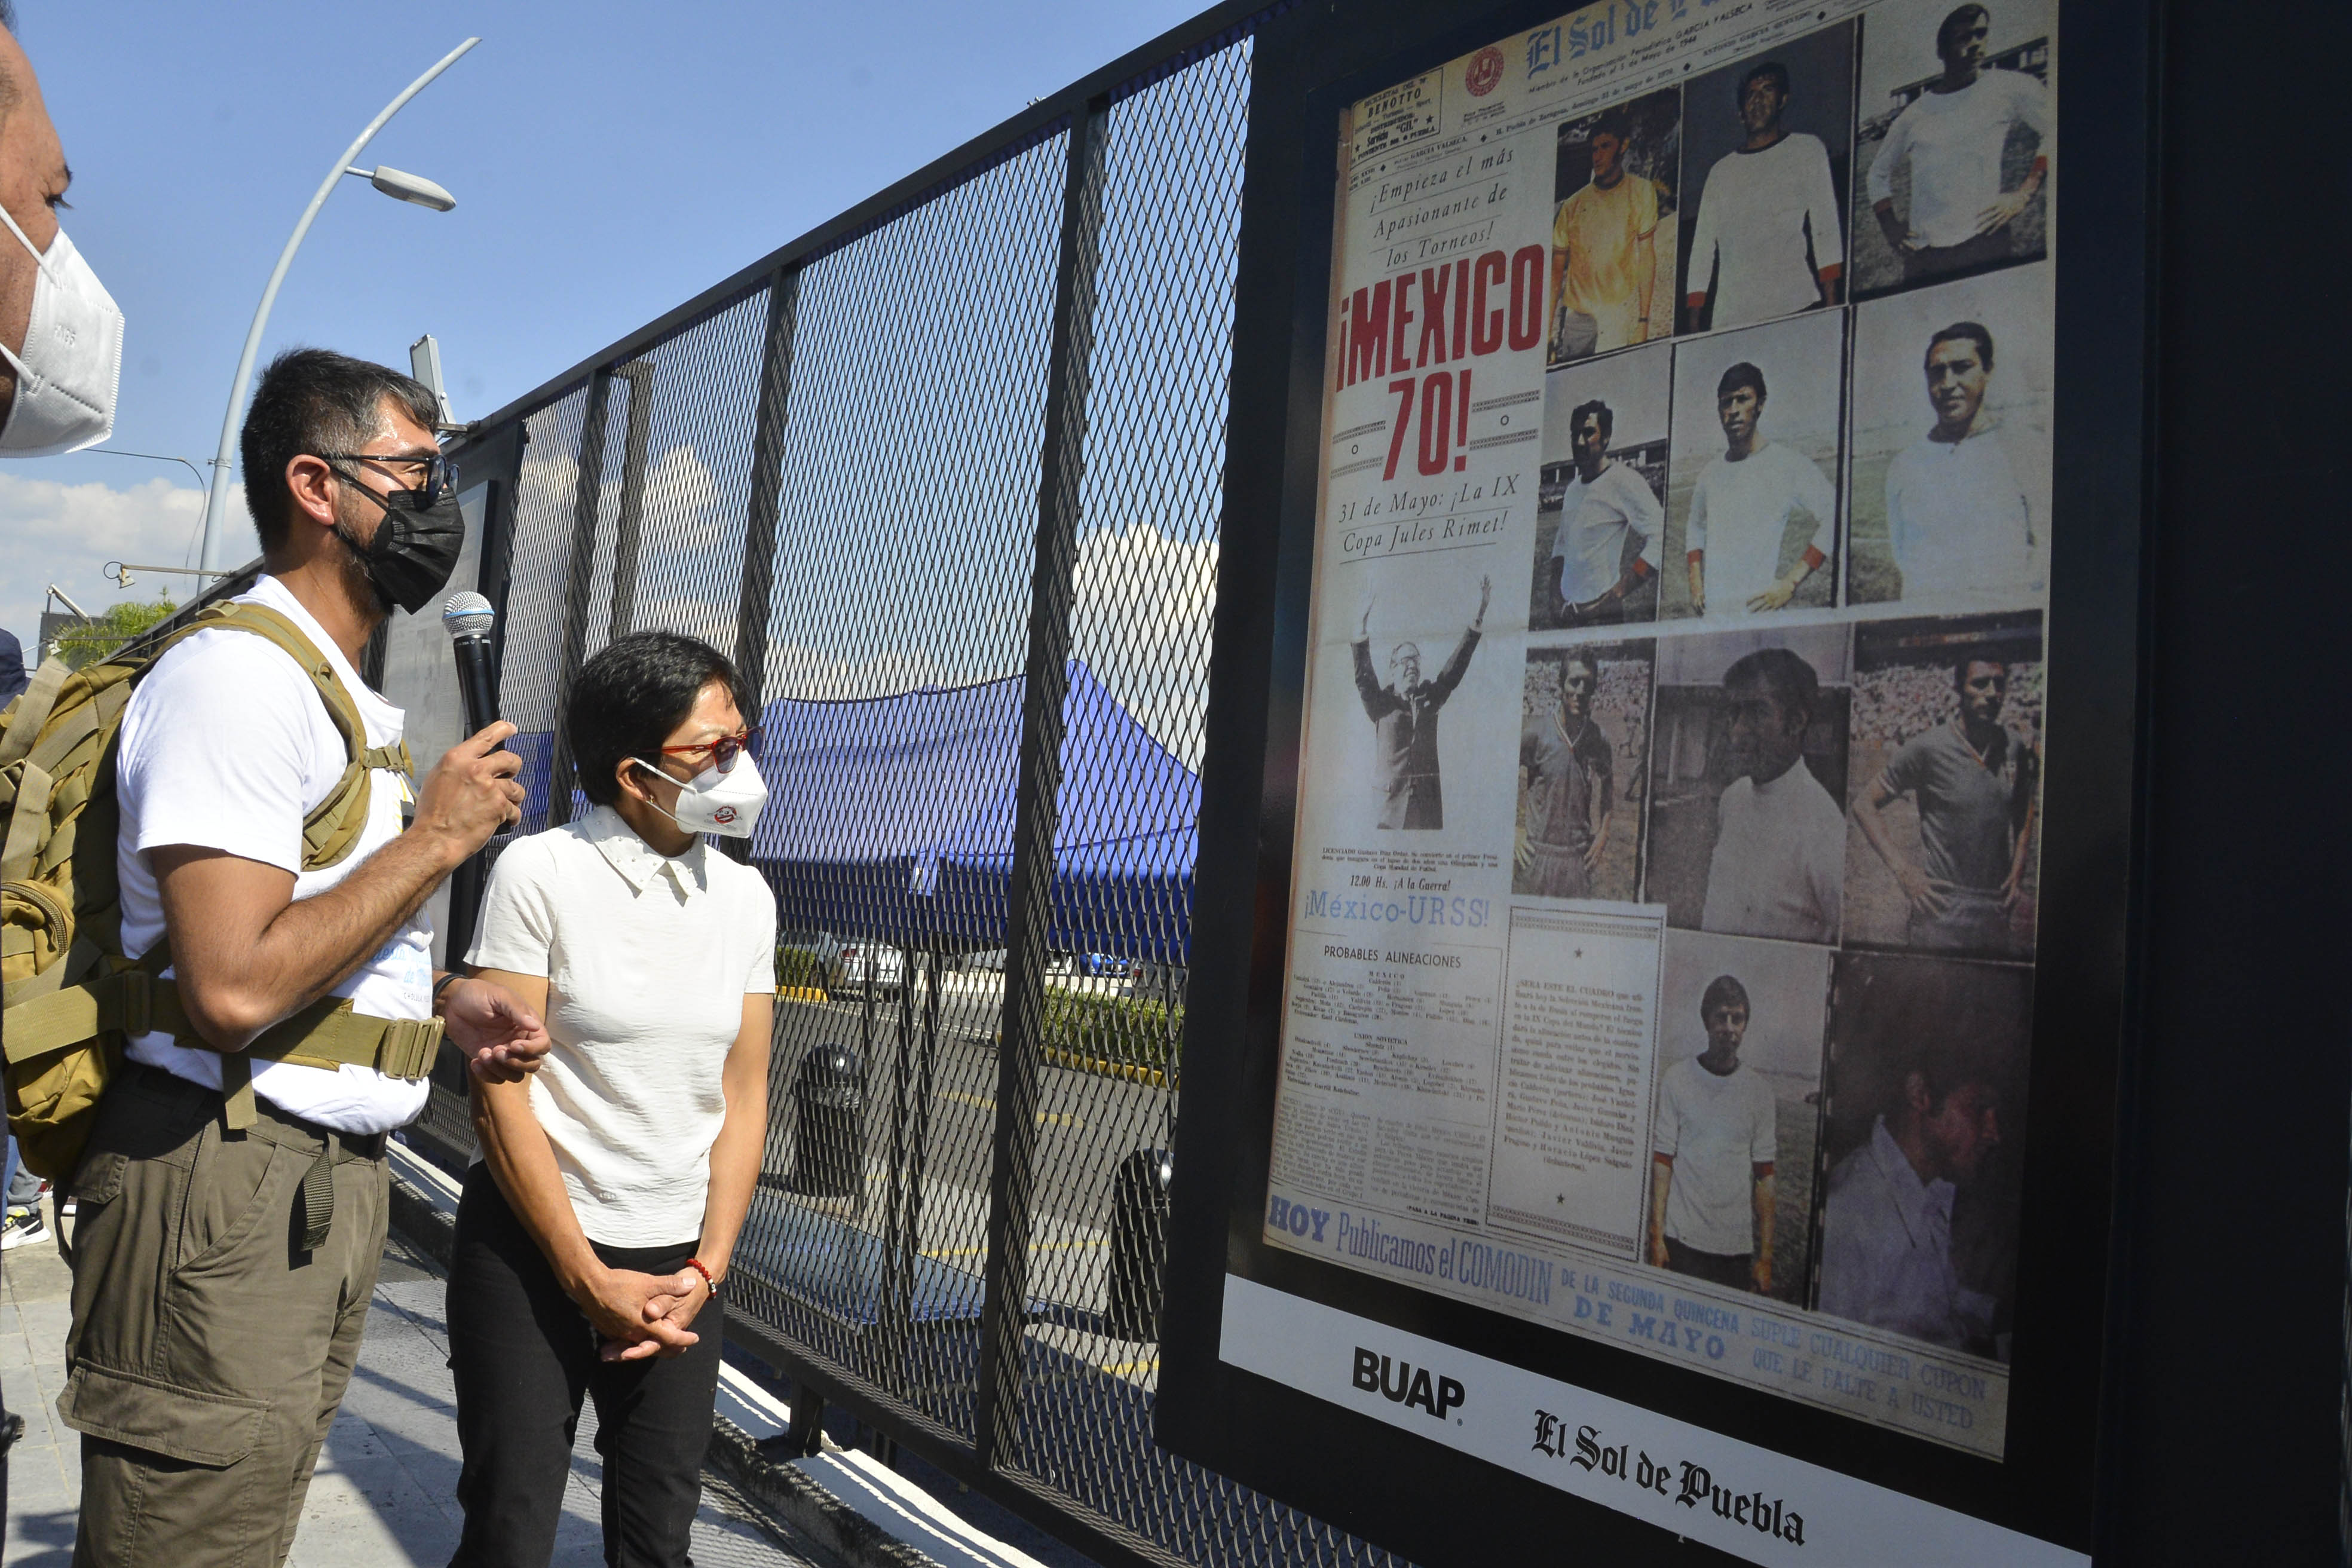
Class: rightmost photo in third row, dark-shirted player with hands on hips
1846,614,2041,957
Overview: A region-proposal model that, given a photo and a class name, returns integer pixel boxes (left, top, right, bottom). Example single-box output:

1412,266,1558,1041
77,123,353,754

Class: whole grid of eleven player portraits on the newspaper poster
1512,0,2056,1361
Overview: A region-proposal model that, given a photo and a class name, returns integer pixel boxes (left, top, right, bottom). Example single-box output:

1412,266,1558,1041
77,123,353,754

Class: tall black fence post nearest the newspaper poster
972,101,1108,1469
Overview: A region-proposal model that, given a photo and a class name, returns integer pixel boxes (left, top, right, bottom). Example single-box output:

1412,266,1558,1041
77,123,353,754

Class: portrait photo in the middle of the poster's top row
1684,42,1854,332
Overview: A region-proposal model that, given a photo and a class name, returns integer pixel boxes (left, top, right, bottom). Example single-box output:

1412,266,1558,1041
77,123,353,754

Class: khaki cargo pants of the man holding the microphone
56,1067,390,1568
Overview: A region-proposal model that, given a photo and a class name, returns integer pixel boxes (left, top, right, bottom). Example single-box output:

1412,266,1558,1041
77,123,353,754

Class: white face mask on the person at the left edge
0,207,122,458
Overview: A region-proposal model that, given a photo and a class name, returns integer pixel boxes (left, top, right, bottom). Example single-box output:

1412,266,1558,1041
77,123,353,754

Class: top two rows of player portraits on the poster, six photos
1529,0,2056,632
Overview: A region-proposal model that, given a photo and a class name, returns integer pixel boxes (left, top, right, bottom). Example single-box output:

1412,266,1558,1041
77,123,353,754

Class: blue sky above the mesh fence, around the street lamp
0,0,1199,642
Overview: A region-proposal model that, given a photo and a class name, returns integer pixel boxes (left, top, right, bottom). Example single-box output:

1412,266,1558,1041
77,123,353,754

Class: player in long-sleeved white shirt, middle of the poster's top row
1682,61,1846,332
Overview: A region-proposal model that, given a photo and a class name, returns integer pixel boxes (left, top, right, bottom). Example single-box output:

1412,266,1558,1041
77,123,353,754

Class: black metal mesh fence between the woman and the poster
406,23,1392,1566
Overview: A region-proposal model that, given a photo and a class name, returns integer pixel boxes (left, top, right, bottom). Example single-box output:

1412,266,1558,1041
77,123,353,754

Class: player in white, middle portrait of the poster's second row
1682,360,1837,616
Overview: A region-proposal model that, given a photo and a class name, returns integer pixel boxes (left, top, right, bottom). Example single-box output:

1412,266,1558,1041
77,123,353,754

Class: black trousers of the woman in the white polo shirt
449,1166,727,1568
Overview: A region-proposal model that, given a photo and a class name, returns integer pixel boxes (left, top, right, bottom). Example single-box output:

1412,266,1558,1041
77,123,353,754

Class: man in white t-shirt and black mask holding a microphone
56,350,548,1568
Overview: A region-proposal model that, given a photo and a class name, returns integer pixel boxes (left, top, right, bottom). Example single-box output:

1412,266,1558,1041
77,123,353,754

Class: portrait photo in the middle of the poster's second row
1658,310,1844,618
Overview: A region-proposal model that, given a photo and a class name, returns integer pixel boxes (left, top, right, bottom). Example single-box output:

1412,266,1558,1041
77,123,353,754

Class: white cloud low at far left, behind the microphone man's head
0,468,261,659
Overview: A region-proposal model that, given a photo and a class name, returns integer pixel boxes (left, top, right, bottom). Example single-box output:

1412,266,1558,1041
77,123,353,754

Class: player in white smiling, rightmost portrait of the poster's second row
1886,322,2041,599
